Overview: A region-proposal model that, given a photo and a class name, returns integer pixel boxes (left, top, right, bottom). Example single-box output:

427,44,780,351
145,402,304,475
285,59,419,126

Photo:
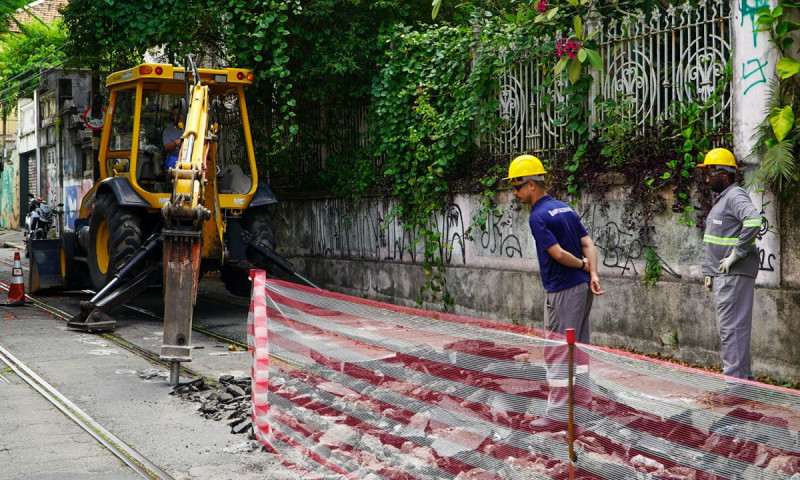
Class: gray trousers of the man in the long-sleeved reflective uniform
712,275,756,380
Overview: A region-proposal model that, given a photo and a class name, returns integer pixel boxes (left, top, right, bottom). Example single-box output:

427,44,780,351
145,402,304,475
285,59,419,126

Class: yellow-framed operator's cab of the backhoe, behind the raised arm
100,65,258,199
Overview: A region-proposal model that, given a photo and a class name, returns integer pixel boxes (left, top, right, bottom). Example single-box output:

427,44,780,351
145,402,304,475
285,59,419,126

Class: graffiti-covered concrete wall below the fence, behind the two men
274,182,800,381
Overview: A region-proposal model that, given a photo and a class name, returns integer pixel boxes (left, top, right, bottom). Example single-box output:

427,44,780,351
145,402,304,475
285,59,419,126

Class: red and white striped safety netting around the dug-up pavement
249,272,800,480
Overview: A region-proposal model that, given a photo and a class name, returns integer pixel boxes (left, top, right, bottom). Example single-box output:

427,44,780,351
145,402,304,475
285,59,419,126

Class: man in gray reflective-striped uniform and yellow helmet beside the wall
698,148,761,392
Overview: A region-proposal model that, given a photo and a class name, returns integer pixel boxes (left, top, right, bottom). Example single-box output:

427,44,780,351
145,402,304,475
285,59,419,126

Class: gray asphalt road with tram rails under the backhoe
0,240,301,480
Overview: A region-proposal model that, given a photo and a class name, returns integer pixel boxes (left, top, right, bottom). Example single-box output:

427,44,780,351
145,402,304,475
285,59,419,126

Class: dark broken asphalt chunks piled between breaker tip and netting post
170,375,255,439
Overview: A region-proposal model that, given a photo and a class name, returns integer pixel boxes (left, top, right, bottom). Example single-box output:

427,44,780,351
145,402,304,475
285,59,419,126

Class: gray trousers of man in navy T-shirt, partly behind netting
544,283,594,422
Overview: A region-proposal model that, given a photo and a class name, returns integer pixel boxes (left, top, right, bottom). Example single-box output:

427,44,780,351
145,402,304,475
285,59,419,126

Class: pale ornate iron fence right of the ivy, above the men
489,0,731,155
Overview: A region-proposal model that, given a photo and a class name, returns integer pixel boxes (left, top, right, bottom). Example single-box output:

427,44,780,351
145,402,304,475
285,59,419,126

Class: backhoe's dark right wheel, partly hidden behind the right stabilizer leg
220,207,275,297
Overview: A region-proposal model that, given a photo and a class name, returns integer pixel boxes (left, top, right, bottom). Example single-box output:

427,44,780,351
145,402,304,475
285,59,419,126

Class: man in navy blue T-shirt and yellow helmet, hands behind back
504,155,605,430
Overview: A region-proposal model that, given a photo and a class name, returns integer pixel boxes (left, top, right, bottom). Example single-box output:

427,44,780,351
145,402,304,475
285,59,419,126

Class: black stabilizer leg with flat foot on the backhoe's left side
67,233,162,332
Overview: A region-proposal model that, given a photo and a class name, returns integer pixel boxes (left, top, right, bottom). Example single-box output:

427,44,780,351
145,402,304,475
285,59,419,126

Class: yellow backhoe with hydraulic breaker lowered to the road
30,57,293,384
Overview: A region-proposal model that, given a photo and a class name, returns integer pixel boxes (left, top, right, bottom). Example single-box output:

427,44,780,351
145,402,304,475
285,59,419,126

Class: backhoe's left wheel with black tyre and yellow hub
88,195,142,290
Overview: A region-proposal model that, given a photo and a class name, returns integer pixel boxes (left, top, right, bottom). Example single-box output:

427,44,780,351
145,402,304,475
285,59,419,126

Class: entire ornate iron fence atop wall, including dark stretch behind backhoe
250,0,731,184
